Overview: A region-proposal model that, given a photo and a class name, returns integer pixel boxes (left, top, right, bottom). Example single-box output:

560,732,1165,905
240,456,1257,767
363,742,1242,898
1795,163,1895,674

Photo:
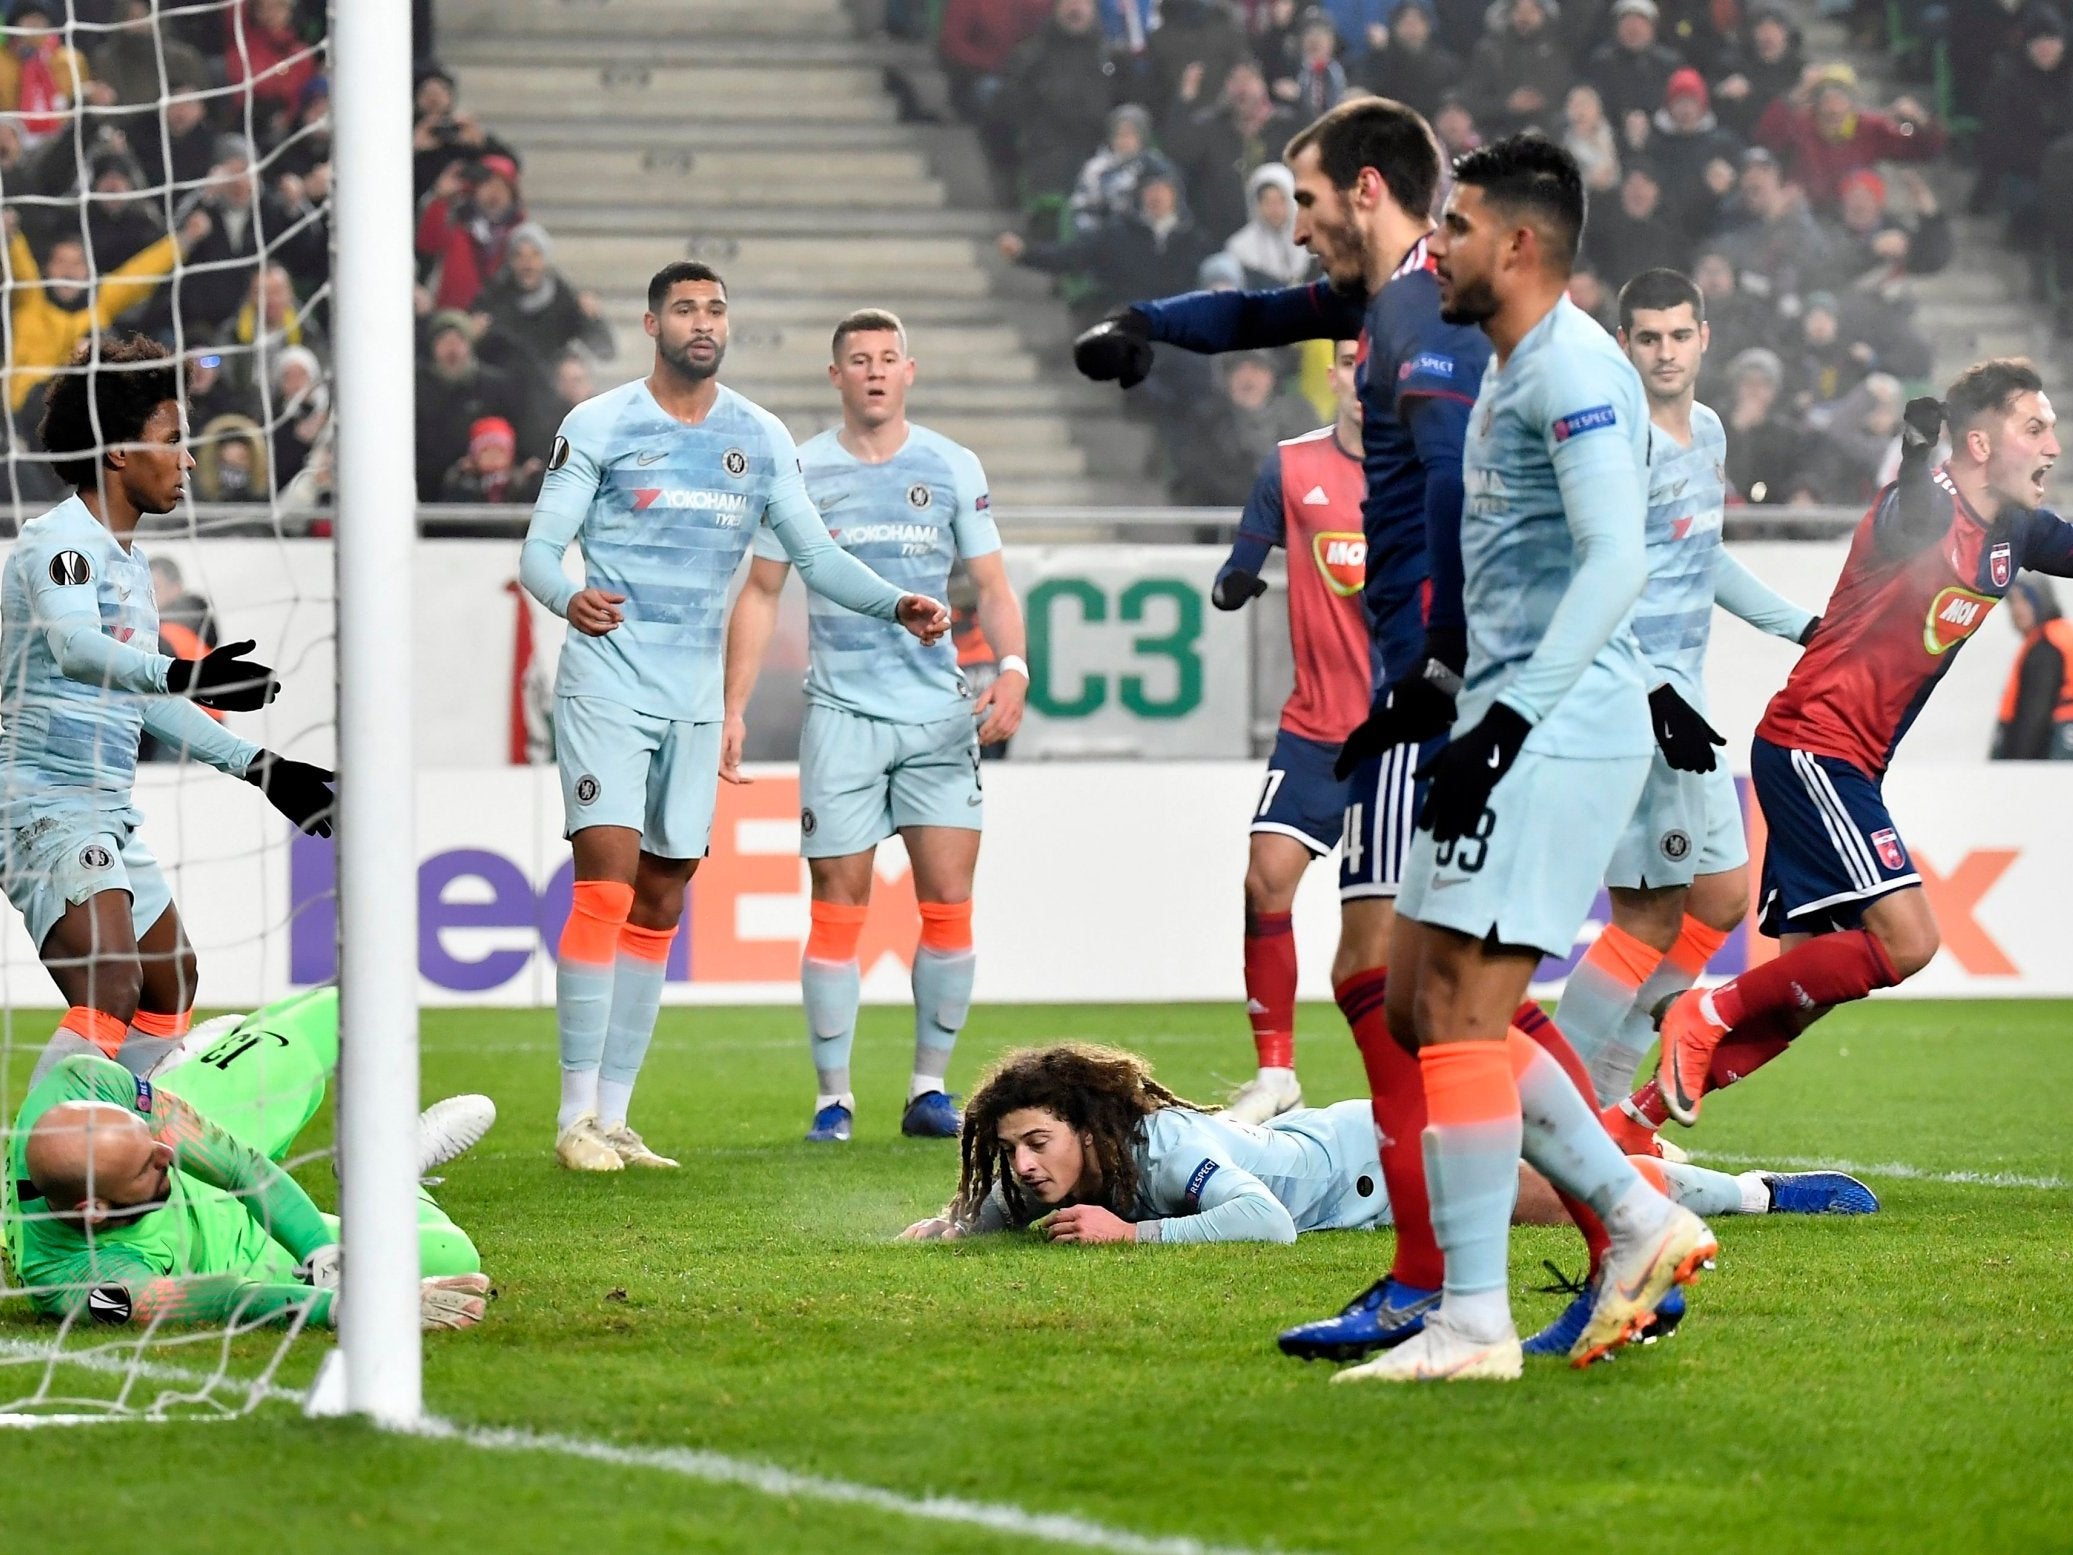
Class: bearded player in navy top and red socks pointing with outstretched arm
1074,97,1573,1358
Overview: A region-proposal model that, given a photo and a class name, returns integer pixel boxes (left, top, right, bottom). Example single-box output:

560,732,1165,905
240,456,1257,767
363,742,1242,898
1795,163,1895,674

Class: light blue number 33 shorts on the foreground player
1397,751,1650,956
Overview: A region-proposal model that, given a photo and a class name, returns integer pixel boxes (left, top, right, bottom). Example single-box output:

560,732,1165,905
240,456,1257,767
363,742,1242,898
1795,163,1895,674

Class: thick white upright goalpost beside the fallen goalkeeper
311,0,423,1424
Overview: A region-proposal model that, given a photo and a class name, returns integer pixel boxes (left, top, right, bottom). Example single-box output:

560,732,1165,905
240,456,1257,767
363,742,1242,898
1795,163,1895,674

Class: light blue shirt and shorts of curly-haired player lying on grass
1134,1101,1389,1242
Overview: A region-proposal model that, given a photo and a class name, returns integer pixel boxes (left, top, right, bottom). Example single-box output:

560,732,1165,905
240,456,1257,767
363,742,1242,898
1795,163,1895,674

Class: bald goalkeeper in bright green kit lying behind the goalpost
0,987,495,1329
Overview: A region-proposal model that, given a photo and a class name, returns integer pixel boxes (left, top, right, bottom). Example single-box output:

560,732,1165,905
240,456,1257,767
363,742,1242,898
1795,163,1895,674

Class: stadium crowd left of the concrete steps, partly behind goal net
0,0,614,533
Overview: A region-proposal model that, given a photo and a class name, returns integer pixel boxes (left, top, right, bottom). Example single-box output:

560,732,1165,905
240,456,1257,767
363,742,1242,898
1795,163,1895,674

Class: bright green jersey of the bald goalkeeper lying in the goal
0,1055,338,1323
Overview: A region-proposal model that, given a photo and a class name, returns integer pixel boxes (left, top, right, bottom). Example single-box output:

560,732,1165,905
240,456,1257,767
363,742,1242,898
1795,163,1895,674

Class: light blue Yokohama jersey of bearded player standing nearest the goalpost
520,379,900,724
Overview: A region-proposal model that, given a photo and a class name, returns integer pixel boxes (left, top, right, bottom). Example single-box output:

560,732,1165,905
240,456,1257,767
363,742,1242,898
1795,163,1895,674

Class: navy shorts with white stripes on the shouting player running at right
1750,740,1922,939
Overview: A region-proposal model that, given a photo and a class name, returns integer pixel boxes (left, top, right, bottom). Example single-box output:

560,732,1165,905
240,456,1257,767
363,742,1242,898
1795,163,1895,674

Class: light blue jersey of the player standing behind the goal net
0,498,168,825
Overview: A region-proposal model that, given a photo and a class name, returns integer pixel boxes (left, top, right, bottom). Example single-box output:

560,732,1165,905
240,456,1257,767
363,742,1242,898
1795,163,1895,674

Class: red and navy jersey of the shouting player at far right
1756,469,2073,778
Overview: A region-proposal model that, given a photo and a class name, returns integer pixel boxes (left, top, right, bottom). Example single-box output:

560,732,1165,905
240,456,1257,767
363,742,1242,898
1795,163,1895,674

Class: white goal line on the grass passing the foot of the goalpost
0,1339,1310,1555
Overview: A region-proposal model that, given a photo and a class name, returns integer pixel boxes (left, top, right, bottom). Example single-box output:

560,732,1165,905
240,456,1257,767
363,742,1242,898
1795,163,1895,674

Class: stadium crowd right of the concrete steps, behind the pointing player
937,0,1965,504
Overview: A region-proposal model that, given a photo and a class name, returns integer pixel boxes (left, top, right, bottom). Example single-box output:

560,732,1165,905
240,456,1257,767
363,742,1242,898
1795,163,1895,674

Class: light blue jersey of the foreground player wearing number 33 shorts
1455,296,1654,757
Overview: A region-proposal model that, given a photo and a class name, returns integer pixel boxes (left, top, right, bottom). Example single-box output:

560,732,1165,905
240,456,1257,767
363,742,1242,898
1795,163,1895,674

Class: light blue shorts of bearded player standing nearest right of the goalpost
553,697,719,858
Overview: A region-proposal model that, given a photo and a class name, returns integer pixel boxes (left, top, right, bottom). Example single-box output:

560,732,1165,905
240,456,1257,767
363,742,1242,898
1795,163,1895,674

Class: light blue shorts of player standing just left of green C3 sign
798,703,985,858
